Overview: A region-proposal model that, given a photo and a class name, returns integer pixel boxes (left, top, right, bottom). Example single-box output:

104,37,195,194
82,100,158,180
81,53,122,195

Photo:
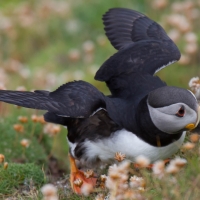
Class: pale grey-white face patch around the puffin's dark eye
148,103,198,134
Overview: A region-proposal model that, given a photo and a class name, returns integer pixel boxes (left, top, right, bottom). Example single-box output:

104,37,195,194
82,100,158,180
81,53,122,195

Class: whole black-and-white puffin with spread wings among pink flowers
0,8,200,194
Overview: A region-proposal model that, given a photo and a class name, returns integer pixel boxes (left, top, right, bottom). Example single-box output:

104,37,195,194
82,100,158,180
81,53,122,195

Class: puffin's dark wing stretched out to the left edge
0,81,105,118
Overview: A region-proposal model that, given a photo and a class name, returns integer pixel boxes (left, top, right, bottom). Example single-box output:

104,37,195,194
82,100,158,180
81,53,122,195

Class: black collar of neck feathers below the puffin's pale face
136,96,182,146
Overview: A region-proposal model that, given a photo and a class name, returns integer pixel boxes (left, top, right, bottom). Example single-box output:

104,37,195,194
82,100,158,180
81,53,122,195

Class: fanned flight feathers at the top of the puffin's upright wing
102,8,171,50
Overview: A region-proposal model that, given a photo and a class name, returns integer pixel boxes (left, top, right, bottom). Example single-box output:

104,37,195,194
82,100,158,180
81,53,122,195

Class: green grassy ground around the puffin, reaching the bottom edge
0,0,200,199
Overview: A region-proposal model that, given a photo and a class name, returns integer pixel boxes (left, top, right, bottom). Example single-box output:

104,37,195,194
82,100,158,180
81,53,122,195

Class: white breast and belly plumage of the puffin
73,129,186,163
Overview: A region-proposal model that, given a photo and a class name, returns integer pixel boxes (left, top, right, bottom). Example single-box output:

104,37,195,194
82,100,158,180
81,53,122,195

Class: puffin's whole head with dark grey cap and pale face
147,86,200,134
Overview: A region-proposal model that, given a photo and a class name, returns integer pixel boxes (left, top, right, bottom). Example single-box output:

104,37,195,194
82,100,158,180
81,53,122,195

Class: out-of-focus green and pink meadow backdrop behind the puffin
0,0,200,180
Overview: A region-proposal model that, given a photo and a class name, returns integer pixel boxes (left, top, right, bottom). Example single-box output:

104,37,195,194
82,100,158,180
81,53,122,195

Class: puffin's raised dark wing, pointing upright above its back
95,8,180,96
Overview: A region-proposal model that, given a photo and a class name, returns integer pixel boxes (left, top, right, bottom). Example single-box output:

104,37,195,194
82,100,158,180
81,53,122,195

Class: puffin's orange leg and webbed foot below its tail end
69,155,97,194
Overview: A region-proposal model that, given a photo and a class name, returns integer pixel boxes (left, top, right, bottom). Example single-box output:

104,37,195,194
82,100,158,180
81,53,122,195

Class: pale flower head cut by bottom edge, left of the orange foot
41,184,58,200
